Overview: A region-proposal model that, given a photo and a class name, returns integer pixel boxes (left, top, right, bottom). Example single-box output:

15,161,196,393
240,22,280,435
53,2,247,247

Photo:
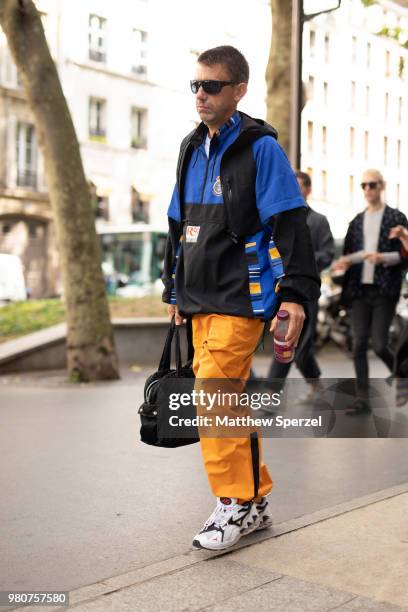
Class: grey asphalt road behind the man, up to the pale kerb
0,351,408,590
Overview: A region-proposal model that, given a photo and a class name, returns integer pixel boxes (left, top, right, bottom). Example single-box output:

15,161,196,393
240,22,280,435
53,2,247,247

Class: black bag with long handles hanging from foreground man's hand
139,318,199,448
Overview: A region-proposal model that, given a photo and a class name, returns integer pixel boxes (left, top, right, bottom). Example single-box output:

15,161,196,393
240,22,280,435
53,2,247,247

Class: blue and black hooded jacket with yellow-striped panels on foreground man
163,112,320,319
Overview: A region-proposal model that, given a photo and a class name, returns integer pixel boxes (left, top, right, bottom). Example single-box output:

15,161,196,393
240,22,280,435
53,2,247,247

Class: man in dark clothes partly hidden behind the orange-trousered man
268,170,334,403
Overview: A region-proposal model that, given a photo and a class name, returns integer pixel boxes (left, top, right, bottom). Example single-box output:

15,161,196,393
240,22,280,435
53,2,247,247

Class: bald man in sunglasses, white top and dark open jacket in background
333,169,407,415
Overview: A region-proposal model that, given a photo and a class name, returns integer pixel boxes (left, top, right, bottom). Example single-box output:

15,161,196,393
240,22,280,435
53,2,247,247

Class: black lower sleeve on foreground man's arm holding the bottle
268,206,320,304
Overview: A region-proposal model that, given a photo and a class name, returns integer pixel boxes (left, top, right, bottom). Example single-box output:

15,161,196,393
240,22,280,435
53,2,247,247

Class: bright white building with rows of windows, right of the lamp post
302,0,408,238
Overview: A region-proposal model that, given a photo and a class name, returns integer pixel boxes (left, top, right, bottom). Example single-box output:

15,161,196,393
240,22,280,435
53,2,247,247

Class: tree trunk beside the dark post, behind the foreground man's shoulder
265,0,292,154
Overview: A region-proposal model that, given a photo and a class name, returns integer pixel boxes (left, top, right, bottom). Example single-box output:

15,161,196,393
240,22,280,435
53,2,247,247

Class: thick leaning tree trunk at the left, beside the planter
0,0,119,381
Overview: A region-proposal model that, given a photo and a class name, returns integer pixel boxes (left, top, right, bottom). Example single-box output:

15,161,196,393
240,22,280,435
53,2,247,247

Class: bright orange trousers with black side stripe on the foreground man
192,314,272,500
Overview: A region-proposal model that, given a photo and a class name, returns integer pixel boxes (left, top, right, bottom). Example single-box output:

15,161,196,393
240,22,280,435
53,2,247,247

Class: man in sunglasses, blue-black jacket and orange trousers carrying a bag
163,46,319,550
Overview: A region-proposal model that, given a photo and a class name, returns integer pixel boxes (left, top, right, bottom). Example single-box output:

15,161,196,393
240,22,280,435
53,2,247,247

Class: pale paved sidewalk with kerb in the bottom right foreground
12,486,408,612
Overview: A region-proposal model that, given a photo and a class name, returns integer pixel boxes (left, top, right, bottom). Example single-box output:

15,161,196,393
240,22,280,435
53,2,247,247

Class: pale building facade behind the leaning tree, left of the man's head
0,0,194,297
